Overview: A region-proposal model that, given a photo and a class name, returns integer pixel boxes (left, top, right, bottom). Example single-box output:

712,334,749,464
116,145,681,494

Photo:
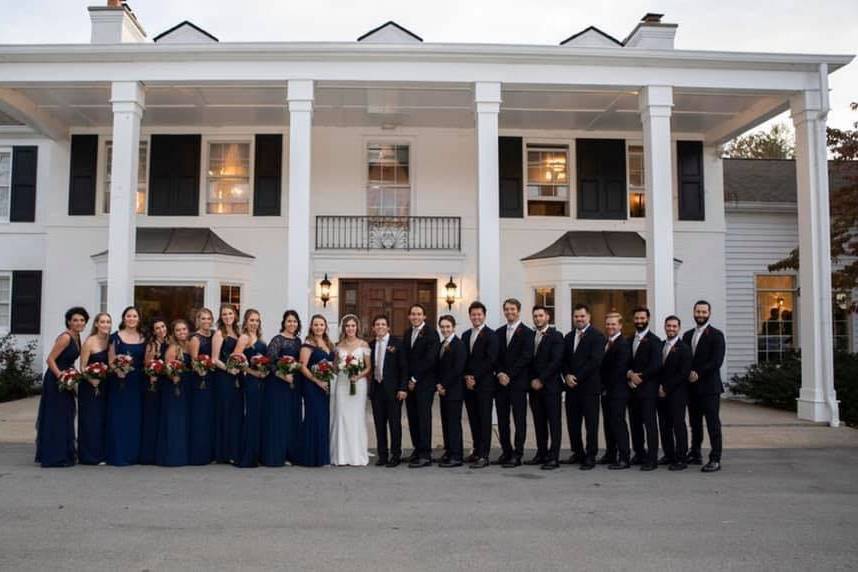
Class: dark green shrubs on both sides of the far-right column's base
730,352,858,426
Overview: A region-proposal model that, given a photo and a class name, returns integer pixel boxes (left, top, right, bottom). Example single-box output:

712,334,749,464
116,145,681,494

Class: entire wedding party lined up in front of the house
31,299,724,472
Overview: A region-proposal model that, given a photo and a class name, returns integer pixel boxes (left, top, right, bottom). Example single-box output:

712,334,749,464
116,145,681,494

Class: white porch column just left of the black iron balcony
286,80,313,320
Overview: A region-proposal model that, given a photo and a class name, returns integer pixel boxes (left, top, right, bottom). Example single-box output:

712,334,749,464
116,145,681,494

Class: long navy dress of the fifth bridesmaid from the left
155,353,194,467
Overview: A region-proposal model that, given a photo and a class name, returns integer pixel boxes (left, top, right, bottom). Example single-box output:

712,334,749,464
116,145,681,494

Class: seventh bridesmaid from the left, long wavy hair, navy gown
212,304,244,463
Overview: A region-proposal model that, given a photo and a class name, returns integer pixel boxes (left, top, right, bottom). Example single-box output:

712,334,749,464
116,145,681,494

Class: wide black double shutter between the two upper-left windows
149,135,201,216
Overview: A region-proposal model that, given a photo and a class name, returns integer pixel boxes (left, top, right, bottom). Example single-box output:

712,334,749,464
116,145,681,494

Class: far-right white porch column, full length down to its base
790,85,840,427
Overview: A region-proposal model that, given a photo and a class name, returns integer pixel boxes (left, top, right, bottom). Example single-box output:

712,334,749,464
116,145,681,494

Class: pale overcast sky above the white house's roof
0,0,858,133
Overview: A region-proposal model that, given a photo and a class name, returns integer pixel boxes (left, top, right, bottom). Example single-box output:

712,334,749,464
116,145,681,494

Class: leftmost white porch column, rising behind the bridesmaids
107,81,145,324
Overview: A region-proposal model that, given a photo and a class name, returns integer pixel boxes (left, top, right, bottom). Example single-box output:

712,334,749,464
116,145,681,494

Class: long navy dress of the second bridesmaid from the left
77,348,108,465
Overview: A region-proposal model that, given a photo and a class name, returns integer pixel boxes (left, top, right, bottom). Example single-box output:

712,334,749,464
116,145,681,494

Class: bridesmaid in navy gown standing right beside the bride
299,314,334,467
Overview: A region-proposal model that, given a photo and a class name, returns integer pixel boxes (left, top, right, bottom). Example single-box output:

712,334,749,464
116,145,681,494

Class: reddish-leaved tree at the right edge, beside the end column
769,103,858,312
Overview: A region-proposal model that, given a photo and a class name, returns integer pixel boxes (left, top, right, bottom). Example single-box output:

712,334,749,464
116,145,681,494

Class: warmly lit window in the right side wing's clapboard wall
756,275,798,363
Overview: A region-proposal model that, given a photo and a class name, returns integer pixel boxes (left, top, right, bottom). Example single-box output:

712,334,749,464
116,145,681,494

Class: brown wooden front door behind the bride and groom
340,278,437,339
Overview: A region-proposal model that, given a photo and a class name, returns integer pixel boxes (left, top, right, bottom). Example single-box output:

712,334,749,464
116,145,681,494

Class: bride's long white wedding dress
331,348,370,466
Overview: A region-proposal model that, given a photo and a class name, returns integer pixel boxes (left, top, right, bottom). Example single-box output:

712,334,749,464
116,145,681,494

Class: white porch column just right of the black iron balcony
474,82,501,323
